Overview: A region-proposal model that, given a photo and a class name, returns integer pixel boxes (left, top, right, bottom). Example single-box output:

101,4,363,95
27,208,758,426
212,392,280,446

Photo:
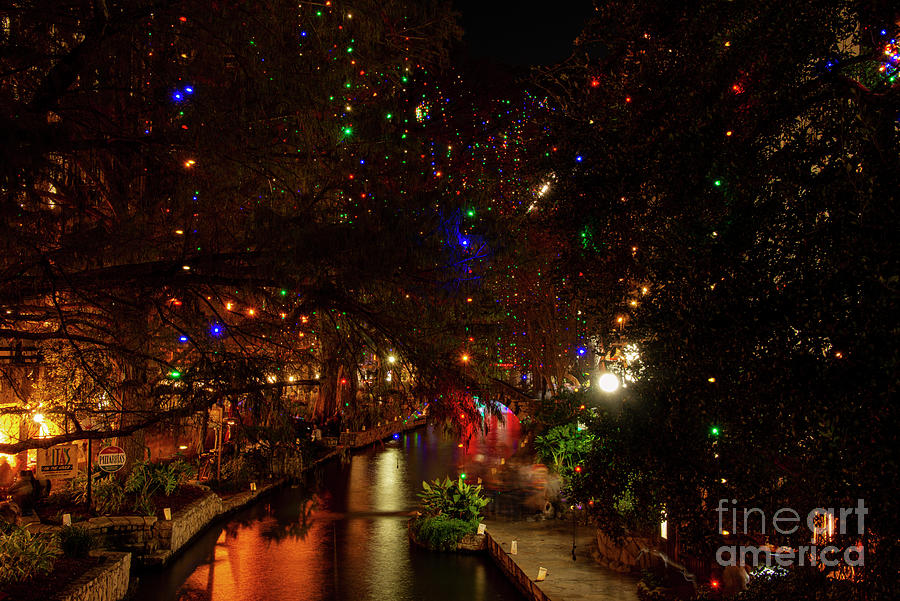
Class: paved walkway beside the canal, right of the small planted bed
485,518,637,601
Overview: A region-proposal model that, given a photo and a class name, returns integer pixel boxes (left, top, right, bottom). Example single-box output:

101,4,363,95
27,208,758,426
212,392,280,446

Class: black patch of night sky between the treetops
453,0,593,67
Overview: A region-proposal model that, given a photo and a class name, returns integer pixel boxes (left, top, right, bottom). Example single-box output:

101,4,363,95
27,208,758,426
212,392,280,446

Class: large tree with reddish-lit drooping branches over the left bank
0,0,512,456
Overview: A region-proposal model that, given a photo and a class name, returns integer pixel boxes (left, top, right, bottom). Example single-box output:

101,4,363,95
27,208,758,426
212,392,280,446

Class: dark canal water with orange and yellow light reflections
135,413,546,601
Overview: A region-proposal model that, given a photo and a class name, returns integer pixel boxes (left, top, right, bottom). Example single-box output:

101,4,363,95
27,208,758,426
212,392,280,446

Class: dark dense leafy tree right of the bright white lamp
538,1,900,594
